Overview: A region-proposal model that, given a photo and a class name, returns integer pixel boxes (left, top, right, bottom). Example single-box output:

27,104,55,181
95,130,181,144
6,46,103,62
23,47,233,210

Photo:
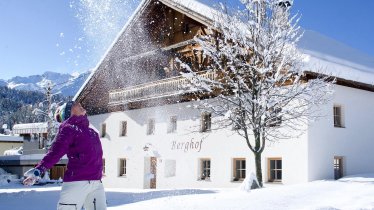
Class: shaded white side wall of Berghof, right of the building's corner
308,85,374,181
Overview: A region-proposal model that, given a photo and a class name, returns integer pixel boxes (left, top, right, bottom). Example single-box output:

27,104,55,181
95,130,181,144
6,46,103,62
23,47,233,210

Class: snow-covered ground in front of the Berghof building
0,174,374,210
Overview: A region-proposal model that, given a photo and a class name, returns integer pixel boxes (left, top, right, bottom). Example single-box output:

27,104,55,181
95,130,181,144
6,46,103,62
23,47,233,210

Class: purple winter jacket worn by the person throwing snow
36,116,103,182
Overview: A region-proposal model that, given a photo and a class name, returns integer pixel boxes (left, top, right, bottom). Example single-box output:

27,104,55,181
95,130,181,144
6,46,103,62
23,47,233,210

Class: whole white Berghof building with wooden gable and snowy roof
75,0,374,188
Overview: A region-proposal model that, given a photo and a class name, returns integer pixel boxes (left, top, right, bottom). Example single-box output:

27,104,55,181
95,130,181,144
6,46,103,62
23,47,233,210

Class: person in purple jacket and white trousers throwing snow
23,101,106,210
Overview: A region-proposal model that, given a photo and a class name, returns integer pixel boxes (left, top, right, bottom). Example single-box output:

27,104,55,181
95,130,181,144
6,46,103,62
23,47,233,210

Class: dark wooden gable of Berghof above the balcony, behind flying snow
77,0,212,115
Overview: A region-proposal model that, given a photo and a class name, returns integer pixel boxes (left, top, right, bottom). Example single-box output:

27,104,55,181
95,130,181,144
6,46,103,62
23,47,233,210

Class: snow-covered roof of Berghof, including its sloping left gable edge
73,0,374,100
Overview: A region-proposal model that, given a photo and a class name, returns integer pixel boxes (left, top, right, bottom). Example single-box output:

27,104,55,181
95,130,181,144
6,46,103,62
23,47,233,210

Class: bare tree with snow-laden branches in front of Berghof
178,0,334,187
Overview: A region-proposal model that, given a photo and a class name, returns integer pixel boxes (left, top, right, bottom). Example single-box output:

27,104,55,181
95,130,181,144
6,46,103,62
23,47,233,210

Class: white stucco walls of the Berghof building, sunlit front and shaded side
89,85,374,188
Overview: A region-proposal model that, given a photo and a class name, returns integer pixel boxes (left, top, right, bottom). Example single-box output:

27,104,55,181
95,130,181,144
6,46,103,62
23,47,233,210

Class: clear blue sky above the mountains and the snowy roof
0,0,374,79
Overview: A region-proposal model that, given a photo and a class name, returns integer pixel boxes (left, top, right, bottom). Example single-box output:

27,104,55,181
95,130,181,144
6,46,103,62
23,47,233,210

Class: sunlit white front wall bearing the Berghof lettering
90,99,307,188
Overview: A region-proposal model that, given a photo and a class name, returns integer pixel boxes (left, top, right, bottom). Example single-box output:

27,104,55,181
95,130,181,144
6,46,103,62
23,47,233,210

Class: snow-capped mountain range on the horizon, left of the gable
0,71,91,96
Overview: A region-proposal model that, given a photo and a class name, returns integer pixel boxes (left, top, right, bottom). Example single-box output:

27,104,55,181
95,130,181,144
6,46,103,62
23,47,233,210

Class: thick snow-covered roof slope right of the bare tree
298,30,374,85
